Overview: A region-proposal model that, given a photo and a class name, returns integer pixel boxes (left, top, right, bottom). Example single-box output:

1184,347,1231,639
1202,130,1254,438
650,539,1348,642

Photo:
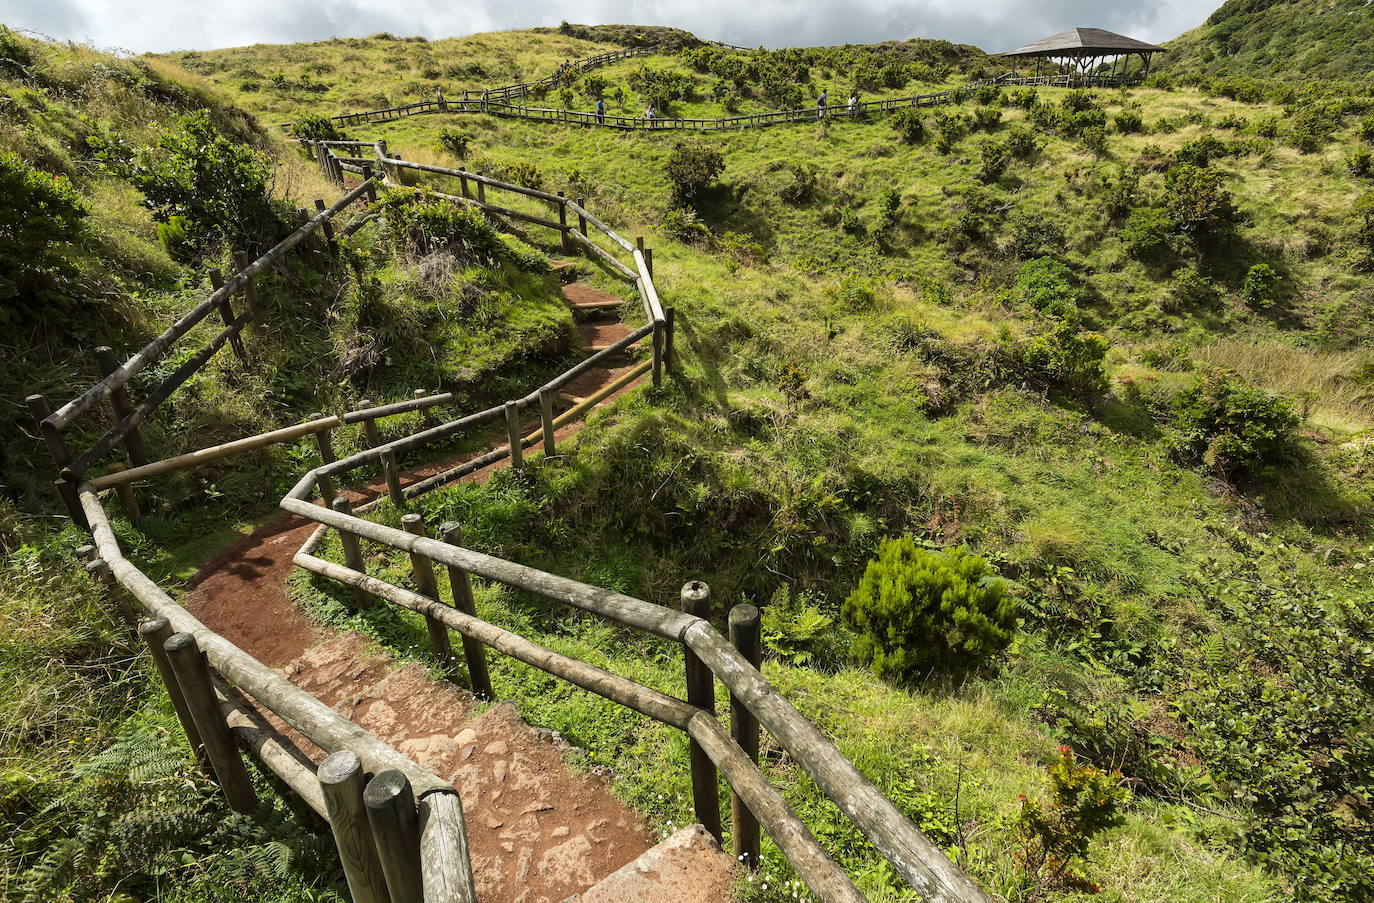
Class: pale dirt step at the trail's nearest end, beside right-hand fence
563,825,739,903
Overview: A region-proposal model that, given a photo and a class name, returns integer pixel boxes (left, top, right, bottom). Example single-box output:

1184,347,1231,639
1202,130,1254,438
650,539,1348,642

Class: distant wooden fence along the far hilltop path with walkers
316,47,1139,132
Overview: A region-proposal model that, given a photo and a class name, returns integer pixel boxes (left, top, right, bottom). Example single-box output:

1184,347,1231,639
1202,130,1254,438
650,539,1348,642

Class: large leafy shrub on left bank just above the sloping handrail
129,110,280,254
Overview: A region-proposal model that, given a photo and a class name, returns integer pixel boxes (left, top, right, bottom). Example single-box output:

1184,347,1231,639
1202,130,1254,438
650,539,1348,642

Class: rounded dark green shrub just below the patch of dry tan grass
1169,370,1300,478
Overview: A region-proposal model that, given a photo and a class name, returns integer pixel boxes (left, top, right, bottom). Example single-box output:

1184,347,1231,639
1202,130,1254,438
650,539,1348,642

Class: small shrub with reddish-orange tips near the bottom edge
1015,746,1131,893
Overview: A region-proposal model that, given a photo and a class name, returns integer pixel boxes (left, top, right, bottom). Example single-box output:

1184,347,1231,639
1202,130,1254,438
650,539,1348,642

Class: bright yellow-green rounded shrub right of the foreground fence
841,536,1018,679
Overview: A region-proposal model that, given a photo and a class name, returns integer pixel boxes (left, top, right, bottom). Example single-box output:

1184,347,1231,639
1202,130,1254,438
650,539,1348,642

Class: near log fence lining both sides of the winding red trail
29,134,991,903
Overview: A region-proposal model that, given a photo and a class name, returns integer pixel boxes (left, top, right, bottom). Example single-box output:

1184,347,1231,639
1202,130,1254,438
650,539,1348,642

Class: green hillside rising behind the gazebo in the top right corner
1161,0,1374,82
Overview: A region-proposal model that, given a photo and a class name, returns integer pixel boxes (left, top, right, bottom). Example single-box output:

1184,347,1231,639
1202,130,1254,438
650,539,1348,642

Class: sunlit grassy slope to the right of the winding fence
177,28,1371,900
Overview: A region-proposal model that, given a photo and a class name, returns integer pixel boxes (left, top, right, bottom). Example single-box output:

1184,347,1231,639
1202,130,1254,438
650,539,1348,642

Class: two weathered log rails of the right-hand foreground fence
282,496,991,903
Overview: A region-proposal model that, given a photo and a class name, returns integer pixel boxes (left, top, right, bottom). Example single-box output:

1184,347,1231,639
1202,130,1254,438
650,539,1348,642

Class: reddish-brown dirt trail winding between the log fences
185,277,654,903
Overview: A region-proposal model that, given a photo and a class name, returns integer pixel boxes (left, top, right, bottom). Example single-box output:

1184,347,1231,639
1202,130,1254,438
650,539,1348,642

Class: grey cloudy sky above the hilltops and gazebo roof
0,0,1220,52
